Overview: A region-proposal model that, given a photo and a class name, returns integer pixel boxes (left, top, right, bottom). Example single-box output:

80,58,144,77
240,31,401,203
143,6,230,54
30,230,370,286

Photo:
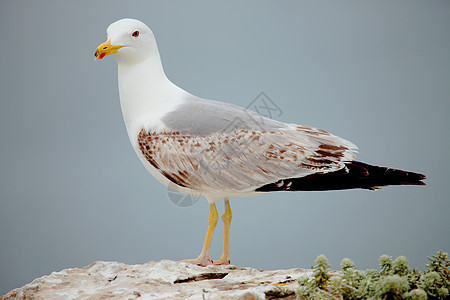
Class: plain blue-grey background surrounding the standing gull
0,0,450,294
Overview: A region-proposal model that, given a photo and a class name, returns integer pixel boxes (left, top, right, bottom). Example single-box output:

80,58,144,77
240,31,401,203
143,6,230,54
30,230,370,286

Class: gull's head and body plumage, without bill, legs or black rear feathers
96,19,356,202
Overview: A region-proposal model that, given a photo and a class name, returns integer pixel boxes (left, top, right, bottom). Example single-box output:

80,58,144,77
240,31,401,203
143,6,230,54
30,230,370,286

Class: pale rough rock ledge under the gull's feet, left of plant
0,260,312,300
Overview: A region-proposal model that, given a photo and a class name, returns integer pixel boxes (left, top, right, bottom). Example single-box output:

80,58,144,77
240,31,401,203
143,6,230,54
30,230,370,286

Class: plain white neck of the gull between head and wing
118,50,189,138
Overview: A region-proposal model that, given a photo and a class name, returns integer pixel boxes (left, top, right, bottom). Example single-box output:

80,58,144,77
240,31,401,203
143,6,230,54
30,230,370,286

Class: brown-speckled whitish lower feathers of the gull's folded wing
137,126,354,192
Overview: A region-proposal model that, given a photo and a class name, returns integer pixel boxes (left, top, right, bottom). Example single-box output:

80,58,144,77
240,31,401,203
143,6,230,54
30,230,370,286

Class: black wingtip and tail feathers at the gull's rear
256,161,426,192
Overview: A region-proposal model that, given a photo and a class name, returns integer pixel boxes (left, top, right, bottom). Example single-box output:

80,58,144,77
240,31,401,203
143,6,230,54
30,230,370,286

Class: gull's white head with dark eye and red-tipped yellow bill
94,19,158,62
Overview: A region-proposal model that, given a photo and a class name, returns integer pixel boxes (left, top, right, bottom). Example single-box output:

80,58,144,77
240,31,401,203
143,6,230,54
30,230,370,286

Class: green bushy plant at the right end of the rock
296,251,450,300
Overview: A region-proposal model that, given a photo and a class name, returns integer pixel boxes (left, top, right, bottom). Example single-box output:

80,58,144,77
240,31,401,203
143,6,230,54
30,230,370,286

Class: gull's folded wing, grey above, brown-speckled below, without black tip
138,101,356,193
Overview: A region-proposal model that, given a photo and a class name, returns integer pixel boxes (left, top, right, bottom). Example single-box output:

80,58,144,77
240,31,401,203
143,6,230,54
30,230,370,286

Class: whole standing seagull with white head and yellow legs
94,19,425,266
